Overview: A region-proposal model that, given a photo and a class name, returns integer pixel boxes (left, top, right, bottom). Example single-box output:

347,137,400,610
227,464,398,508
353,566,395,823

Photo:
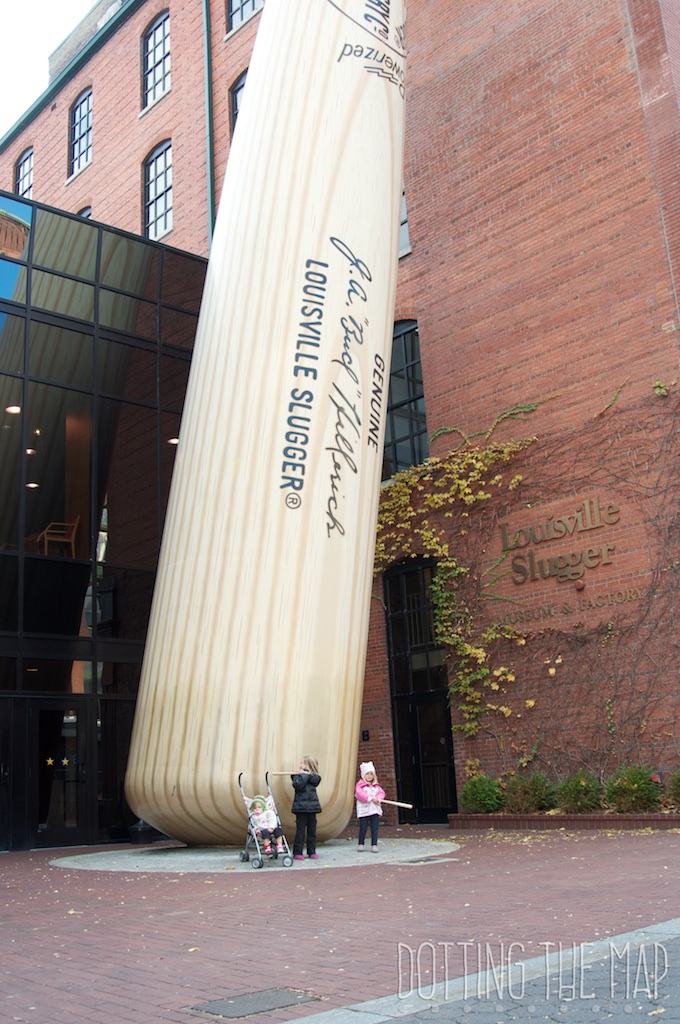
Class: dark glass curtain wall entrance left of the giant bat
0,193,206,849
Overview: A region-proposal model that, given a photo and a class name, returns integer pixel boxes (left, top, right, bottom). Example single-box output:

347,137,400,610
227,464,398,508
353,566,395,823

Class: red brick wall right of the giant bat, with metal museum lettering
369,0,680,792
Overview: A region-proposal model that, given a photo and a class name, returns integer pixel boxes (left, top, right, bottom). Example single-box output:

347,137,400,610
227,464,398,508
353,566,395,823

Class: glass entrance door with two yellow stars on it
29,698,91,847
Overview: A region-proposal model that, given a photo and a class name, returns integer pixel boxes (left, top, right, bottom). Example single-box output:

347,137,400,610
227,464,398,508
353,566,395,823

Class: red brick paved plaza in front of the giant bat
0,826,680,1024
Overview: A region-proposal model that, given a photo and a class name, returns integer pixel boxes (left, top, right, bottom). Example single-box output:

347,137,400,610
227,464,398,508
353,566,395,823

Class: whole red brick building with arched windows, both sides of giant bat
0,0,680,820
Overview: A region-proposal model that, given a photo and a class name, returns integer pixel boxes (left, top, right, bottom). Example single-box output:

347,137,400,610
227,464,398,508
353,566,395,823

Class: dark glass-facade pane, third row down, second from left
29,321,94,388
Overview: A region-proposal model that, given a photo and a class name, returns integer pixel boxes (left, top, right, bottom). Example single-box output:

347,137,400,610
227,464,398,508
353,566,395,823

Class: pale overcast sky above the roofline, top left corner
0,0,94,137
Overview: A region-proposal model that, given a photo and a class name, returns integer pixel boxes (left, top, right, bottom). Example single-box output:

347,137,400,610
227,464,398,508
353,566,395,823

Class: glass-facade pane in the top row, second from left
33,210,97,281
